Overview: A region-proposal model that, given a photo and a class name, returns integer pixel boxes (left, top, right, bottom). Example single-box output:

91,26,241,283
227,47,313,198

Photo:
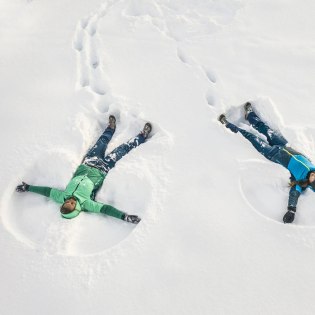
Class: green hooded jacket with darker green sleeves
29,164,125,219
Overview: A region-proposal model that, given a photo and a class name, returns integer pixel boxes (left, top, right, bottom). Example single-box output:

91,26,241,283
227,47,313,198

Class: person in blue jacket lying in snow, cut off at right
218,102,315,223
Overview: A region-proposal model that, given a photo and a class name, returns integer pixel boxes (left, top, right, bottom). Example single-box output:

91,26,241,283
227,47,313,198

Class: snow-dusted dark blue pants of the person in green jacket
83,127,145,173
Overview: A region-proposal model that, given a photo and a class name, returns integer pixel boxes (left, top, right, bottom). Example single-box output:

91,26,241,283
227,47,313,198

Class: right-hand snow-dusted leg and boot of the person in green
103,123,152,172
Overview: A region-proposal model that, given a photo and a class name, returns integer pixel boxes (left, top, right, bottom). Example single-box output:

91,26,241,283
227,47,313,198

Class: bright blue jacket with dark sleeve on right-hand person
281,147,315,210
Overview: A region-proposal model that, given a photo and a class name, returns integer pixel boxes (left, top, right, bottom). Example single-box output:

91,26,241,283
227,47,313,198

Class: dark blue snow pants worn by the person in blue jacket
226,112,288,165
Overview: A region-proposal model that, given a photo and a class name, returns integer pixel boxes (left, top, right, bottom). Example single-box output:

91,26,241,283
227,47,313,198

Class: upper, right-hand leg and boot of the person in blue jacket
245,103,288,146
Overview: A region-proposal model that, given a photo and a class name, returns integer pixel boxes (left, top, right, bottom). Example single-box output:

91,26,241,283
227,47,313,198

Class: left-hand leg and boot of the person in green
84,115,116,159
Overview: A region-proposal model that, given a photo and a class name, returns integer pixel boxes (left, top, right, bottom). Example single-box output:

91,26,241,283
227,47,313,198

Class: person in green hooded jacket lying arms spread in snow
16,115,152,224
